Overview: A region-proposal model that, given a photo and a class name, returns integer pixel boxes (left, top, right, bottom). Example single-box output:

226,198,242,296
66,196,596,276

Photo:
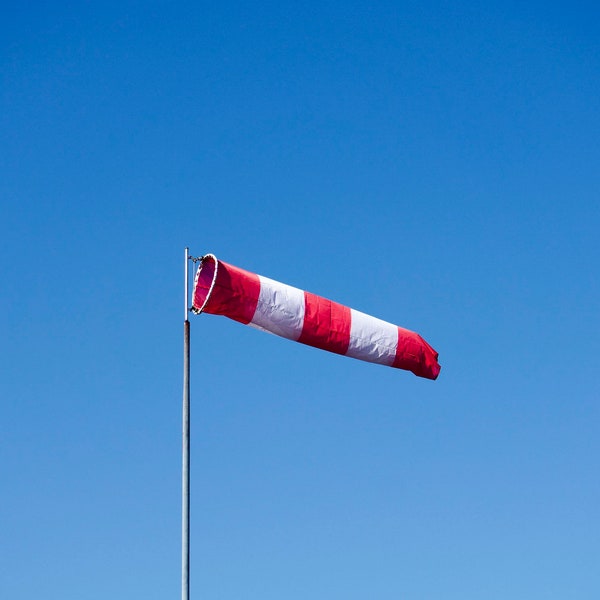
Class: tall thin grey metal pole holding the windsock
181,248,190,600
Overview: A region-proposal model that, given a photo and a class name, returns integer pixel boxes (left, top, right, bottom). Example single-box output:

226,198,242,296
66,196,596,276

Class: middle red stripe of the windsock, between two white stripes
298,292,350,354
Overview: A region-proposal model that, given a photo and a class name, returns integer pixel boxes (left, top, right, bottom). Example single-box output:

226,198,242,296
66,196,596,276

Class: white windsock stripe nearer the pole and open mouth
249,275,304,340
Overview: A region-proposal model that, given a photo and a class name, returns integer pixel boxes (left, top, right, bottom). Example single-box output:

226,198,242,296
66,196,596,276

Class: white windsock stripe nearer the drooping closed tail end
346,308,398,366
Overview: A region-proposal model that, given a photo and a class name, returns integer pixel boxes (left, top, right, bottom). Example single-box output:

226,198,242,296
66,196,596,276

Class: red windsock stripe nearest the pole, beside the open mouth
198,260,260,325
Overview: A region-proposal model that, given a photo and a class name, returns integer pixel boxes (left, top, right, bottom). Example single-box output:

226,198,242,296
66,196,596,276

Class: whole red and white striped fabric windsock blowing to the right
192,254,440,379
